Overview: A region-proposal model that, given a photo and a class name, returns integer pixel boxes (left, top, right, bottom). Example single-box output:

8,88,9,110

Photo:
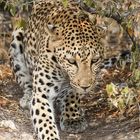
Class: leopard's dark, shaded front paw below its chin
60,117,88,133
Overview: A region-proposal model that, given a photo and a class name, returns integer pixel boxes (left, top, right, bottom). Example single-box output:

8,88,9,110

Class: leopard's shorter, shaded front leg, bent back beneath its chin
60,90,88,133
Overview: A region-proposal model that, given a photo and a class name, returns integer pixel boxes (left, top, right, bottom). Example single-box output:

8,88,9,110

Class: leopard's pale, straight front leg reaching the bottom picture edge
31,56,62,140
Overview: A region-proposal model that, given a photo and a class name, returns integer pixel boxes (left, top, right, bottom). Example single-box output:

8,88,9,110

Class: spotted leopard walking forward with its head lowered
9,0,122,140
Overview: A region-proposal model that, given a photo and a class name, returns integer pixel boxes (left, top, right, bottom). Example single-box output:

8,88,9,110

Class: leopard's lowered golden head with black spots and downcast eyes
46,13,104,92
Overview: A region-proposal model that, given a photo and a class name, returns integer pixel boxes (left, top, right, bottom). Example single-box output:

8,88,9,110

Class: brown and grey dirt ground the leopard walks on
0,65,140,140
